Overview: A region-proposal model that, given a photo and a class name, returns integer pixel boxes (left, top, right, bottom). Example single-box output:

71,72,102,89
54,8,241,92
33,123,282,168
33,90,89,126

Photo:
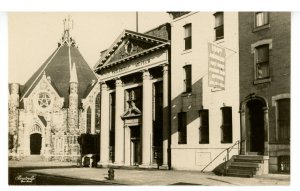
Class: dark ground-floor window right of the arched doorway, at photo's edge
277,98,290,141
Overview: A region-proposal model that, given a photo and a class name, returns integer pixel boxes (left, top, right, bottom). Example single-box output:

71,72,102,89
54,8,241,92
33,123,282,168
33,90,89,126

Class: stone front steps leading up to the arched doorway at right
224,155,268,178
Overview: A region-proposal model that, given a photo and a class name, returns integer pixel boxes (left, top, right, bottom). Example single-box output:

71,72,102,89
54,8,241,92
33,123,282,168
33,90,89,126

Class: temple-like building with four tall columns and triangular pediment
95,24,170,168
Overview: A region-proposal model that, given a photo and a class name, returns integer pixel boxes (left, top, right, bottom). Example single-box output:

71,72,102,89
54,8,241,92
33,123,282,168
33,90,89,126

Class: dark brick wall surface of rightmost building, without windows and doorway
239,12,291,172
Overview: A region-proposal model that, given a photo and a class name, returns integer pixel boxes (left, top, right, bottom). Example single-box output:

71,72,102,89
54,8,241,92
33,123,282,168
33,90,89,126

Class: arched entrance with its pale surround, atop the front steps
240,94,269,155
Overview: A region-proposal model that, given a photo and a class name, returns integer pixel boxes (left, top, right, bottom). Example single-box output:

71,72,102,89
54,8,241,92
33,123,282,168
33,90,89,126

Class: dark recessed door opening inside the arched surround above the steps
246,99,264,154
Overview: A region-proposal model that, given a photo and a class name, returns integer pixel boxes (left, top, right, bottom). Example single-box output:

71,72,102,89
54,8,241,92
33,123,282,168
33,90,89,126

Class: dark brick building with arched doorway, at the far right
238,12,291,172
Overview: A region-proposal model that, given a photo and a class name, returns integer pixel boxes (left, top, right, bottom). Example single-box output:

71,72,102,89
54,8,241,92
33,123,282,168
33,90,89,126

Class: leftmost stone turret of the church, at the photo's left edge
8,83,20,157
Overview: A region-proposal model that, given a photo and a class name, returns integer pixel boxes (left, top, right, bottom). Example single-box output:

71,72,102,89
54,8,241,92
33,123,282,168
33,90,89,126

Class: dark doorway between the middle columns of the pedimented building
130,125,142,166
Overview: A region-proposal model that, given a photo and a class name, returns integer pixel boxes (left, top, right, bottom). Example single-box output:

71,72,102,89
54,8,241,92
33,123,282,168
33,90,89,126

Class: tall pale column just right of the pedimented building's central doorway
142,70,152,168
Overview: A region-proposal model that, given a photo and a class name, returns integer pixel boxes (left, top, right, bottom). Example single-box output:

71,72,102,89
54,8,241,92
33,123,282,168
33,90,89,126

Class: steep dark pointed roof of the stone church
20,18,97,107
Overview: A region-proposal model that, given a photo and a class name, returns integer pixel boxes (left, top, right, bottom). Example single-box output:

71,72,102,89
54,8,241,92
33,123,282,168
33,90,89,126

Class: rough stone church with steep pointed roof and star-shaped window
9,20,100,161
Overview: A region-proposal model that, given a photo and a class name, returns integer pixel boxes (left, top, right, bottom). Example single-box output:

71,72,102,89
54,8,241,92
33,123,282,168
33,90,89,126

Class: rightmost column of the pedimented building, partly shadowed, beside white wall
162,64,170,168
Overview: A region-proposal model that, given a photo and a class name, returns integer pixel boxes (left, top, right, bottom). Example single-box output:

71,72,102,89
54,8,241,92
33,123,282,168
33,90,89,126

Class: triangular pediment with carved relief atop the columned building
96,30,169,68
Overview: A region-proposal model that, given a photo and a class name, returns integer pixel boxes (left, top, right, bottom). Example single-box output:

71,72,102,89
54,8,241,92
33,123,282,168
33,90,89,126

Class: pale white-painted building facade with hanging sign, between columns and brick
169,12,240,171
